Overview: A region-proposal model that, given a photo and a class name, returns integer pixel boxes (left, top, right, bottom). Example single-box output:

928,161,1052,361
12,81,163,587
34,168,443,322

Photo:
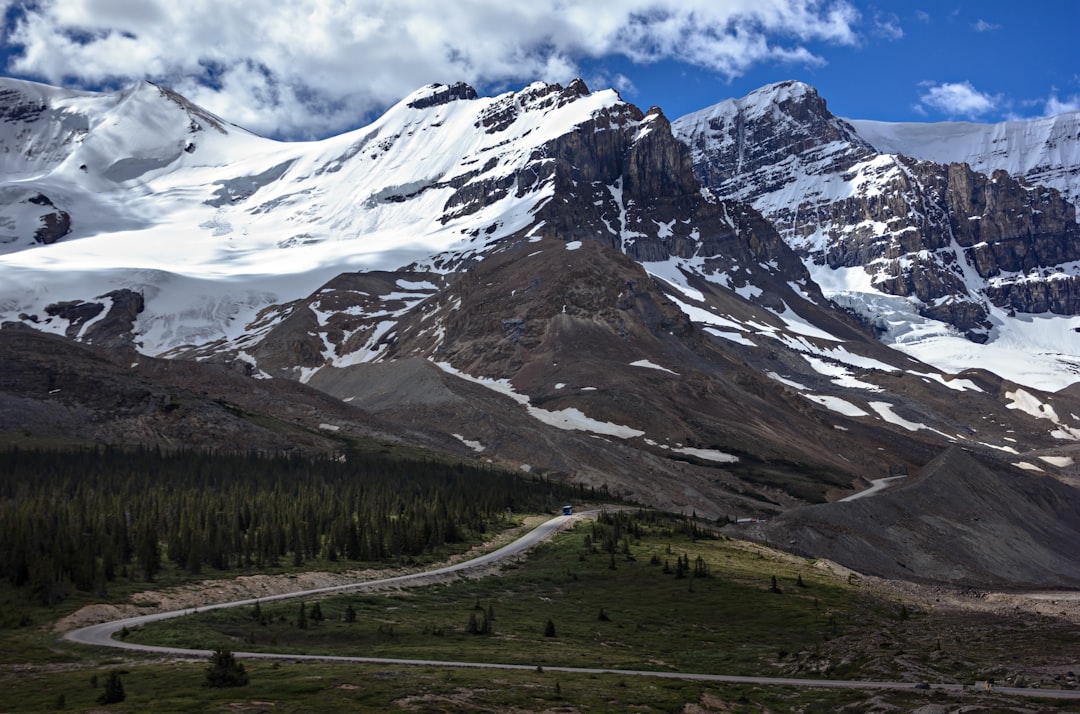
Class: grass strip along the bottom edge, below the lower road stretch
0,662,980,714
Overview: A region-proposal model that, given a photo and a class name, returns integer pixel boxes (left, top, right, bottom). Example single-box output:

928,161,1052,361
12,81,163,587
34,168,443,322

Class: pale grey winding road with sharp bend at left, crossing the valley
64,511,1080,700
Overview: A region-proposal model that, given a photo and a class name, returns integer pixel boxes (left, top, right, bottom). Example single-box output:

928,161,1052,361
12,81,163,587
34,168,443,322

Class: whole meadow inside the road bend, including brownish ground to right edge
122,518,1080,684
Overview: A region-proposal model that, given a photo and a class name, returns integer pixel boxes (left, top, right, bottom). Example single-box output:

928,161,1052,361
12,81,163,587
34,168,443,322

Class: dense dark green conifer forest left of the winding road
0,446,595,605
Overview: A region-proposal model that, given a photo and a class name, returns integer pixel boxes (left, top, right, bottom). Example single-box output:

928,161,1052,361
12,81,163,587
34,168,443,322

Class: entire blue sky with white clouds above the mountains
0,0,1080,138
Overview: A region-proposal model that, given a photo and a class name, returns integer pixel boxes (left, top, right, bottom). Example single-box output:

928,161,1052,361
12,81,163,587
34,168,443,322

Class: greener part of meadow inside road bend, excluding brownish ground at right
131,529,864,674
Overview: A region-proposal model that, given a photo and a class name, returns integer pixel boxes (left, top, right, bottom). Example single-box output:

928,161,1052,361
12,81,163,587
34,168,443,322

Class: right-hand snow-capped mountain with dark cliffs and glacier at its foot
673,82,1080,386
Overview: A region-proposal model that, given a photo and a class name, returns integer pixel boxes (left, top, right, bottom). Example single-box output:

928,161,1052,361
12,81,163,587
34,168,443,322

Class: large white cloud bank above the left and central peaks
0,0,860,137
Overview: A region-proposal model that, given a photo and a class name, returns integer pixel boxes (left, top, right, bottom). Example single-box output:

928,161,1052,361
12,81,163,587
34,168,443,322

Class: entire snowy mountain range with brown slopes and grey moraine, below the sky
0,79,1080,588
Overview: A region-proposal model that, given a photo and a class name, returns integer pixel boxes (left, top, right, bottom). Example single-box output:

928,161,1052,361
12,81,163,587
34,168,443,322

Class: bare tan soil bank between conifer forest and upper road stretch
52,515,548,632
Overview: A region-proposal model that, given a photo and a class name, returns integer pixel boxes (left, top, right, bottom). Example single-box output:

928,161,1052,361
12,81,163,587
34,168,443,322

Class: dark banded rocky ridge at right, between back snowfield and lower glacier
674,82,1080,341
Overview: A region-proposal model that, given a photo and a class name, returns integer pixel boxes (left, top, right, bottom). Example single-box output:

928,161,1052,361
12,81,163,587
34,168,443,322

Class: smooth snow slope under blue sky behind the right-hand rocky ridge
848,111,1080,204
